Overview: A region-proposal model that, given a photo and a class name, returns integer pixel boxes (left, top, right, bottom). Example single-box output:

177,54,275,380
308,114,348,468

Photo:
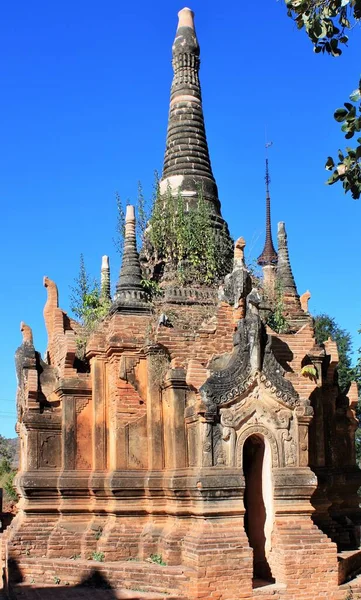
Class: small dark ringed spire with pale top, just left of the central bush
113,205,148,311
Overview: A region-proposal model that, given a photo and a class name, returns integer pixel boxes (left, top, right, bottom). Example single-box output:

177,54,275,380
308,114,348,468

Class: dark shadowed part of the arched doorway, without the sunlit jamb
243,435,274,583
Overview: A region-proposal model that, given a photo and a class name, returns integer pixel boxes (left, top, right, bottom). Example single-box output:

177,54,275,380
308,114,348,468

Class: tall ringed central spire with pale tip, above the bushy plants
160,8,223,218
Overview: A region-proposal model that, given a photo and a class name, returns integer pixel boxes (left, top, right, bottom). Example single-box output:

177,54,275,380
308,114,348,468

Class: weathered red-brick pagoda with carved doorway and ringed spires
3,9,361,600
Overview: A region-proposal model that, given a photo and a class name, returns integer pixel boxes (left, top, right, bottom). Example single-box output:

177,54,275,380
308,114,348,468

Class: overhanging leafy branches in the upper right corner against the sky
286,0,361,199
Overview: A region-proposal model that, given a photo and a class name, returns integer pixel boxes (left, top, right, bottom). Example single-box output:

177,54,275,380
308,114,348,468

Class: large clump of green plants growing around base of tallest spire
146,186,233,284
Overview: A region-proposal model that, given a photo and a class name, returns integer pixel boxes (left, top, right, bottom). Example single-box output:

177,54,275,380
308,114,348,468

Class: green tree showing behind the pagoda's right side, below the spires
315,314,354,392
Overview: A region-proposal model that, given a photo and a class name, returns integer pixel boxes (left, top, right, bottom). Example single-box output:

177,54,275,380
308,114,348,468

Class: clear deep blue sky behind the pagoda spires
0,0,361,436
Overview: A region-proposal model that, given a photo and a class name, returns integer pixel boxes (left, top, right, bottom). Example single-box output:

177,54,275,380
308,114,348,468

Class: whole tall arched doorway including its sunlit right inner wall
243,434,274,581
